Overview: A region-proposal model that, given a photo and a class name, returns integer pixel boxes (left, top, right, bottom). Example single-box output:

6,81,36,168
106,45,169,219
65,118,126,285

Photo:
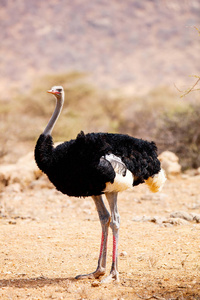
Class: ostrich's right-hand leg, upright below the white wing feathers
102,192,120,283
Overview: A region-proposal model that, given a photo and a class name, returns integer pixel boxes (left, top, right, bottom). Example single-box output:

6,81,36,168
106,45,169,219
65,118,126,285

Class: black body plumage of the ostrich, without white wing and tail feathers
35,132,160,197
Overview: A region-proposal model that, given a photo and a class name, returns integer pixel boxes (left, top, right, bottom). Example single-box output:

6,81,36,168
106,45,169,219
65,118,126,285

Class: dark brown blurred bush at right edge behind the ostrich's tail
157,104,200,169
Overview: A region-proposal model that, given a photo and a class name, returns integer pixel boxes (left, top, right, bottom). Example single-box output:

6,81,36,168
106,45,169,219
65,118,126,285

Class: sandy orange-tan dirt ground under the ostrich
0,172,200,300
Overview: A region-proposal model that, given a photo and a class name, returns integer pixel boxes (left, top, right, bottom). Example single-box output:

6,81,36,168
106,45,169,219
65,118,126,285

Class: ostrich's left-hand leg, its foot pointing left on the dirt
76,196,110,279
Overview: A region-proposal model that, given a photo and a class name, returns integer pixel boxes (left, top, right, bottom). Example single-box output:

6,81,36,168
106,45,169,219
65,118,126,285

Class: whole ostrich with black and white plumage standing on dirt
35,86,165,282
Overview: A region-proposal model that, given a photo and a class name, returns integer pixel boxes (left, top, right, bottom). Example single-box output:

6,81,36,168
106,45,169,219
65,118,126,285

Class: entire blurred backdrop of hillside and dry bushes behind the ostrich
0,0,200,169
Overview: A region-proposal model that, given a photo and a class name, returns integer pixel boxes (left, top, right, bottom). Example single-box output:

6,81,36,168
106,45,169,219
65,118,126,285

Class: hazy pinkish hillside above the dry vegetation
0,0,200,97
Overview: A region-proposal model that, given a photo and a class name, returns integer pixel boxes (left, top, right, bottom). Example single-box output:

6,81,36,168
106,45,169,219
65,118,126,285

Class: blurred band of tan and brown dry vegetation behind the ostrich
0,72,200,169
